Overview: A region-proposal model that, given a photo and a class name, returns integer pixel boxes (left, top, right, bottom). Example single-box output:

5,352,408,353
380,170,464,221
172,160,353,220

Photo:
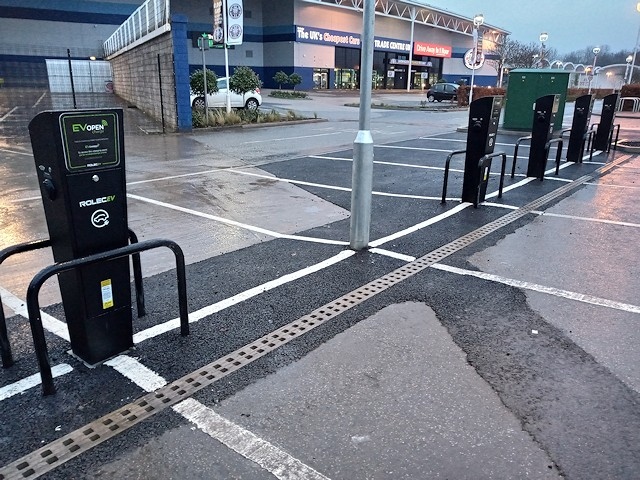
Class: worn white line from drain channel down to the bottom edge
178,398,328,480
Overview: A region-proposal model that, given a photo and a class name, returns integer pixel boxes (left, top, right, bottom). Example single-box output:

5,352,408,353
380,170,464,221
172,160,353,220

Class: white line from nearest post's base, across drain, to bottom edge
105,355,328,480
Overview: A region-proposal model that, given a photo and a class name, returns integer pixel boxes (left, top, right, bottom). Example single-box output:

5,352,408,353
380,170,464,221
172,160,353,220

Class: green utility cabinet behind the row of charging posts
502,68,570,131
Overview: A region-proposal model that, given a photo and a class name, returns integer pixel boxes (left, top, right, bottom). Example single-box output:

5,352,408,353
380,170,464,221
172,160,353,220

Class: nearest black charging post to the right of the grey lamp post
462,96,504,204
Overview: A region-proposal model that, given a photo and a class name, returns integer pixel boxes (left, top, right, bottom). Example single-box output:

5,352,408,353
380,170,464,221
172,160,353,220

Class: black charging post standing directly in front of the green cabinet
527,95,560,179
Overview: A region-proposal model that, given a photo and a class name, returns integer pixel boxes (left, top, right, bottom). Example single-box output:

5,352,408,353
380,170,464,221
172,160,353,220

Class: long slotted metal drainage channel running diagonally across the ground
0,155,631,480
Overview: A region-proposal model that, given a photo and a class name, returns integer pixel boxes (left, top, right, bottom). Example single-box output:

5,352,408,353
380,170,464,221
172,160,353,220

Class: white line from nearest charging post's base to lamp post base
133,250,356,344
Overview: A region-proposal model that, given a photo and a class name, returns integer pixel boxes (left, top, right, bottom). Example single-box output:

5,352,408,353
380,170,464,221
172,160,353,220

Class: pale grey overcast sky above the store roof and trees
421,0,640,54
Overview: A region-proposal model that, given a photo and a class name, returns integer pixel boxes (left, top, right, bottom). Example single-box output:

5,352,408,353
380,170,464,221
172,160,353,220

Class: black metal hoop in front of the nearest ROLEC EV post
27,240,189,395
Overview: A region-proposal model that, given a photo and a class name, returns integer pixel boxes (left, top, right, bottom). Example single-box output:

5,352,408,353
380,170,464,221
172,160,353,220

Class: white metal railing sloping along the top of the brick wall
104,0,171,57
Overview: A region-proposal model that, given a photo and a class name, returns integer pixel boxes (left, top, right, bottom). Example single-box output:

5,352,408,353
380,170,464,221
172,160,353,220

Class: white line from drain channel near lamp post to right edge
431,263,640,313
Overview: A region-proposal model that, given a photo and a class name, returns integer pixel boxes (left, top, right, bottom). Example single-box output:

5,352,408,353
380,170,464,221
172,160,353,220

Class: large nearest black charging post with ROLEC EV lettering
29,109,133,364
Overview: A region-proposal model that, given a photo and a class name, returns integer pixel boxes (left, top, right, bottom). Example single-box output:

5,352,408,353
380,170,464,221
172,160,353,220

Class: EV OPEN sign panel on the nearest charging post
60,113,120,172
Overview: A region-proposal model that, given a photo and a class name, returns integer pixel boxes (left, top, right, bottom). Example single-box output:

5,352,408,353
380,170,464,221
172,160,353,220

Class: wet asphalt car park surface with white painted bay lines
0,87,640,479
